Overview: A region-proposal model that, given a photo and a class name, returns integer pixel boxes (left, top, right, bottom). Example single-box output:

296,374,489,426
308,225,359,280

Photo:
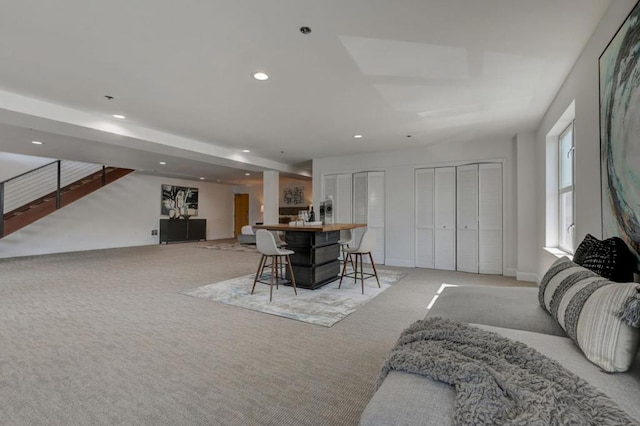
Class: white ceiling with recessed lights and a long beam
0,0,610,183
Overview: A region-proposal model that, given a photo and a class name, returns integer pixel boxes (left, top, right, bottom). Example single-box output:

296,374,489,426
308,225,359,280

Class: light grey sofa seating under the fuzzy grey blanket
360,286,640,426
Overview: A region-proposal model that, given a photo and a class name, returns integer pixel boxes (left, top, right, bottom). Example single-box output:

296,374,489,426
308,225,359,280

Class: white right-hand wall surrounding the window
536,0,636,278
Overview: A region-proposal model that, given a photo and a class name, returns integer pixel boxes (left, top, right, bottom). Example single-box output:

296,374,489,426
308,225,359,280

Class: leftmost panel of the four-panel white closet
416,169,435,268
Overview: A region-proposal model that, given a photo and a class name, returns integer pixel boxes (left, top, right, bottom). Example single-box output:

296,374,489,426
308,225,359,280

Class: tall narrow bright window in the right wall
558,121,575,253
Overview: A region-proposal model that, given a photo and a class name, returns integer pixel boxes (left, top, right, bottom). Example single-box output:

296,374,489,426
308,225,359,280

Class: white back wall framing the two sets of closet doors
313,139,520,275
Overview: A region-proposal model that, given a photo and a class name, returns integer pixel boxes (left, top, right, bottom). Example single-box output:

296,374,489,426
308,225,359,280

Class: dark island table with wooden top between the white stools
254,223,367,290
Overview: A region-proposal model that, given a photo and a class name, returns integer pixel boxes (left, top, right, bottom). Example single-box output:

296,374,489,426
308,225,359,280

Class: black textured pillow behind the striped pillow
574,237,635,282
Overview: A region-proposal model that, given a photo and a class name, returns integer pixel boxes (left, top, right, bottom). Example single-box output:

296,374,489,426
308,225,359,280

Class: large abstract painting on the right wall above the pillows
599,0,640,266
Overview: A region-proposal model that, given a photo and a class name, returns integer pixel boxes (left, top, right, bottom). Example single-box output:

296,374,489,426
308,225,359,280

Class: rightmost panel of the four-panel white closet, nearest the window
478,164,502,274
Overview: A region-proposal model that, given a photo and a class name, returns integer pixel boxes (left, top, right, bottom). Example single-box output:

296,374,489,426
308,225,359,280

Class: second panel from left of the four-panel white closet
434,167,456,271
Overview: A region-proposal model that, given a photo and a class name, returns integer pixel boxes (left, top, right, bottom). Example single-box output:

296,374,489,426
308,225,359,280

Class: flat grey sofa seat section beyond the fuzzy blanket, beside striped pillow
427,285,566,336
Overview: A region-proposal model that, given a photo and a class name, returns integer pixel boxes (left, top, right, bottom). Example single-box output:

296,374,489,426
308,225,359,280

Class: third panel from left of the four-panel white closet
456,164,478,274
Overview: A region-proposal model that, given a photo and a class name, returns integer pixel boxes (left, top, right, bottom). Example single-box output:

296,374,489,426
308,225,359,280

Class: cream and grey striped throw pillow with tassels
538,257,640,373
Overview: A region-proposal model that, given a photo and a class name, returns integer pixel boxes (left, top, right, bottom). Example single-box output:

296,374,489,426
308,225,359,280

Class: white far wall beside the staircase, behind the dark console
0,173,233,258
